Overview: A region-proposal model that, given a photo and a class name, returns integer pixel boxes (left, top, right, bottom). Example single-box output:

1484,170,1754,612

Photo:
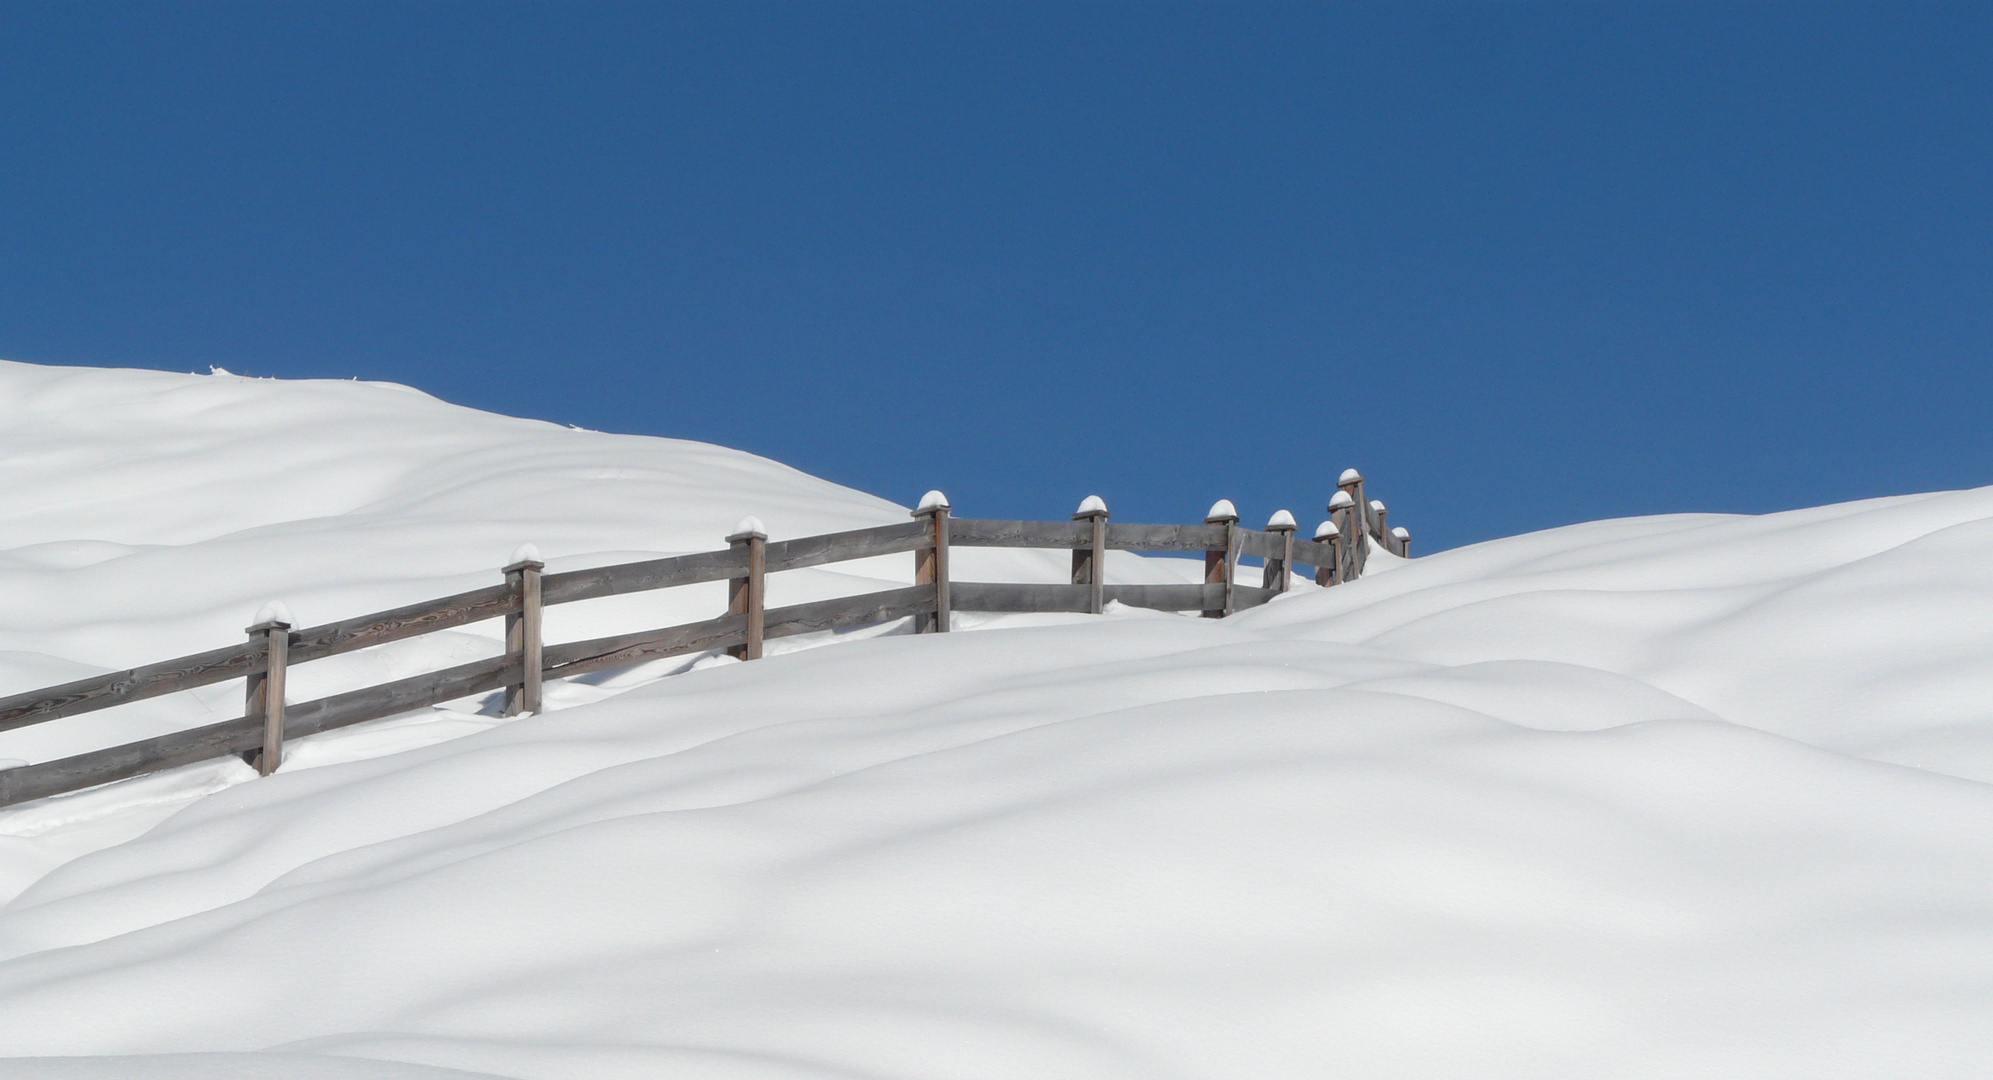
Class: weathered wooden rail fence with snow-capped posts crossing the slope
0,468,1411,807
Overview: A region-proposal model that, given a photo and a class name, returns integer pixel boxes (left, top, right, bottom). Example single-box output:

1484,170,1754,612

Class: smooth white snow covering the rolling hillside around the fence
0,367,1993,1080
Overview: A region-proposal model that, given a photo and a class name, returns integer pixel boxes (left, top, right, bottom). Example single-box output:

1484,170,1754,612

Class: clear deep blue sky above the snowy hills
0,0,1993,552
